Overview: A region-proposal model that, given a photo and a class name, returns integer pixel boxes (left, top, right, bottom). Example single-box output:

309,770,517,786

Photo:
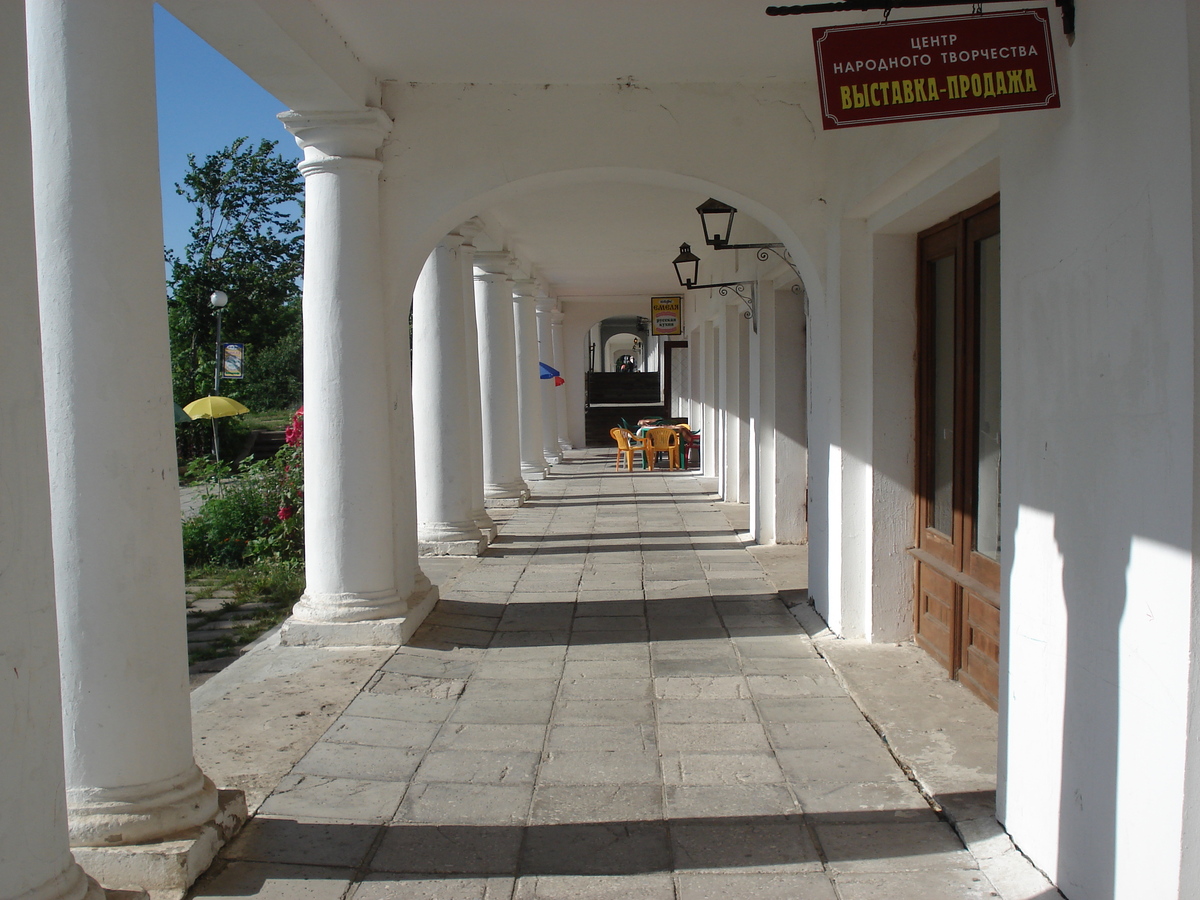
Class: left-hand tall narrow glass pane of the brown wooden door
930,257,954,535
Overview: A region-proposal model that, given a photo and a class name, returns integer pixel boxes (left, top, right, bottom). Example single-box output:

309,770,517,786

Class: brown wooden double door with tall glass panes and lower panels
913,198,1001,707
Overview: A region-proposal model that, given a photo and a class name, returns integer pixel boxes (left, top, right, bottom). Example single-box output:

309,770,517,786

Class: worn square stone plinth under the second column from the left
72,791,247,900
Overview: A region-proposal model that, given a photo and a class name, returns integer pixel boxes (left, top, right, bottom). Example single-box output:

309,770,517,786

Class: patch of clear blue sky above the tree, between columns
154,6,300,260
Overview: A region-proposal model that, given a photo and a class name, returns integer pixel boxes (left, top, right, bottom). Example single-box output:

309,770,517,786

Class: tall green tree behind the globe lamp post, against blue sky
167,138,304,409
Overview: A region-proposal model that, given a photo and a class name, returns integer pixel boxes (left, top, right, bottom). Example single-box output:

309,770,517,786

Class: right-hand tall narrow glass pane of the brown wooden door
974,234,1000,562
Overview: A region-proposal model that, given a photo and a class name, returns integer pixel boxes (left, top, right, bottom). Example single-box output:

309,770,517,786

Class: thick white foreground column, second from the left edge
24,0,224,877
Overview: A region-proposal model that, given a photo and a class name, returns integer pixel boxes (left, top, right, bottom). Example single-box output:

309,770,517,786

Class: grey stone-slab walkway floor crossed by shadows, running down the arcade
194,454,1049,900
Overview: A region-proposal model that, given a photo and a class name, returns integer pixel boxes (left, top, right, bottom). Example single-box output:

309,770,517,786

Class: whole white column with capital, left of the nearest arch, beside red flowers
280,109,428,646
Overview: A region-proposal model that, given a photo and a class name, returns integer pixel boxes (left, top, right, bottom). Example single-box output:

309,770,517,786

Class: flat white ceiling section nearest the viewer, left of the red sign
314,0,812,84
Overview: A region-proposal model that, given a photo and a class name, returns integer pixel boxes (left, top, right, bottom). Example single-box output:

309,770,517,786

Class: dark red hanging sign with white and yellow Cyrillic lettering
812,10,1058,130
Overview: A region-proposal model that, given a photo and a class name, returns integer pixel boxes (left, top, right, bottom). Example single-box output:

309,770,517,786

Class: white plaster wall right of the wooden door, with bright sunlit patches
1001,0,1195,900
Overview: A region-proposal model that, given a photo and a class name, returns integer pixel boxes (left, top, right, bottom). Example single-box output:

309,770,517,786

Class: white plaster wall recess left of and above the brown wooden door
809,116,1000,641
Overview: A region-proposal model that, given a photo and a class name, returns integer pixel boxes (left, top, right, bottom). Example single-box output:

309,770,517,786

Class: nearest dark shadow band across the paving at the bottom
200,808,988,889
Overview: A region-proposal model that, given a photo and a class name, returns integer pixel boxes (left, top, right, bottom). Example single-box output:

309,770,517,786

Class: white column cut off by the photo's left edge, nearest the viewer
0,0,103,900
